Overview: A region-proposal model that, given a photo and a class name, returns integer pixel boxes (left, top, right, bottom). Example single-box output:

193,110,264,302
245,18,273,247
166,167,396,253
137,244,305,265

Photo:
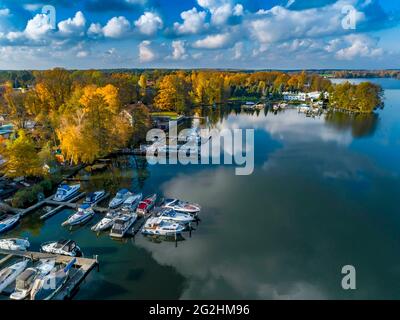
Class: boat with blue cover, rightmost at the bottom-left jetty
31,258,76,300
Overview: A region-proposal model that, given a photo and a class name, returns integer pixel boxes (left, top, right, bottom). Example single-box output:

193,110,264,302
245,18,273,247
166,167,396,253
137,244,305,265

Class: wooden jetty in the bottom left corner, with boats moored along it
0,250,99,300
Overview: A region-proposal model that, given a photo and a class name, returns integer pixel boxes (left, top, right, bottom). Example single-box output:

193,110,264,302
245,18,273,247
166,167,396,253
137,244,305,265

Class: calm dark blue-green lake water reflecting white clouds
2,79,400,299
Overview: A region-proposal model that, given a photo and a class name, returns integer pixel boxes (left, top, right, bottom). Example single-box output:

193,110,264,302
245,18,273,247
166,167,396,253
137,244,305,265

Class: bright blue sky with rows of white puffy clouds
0,0,400,70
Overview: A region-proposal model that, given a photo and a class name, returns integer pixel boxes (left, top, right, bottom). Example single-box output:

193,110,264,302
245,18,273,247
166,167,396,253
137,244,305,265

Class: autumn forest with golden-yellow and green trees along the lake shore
0,68,382,177
